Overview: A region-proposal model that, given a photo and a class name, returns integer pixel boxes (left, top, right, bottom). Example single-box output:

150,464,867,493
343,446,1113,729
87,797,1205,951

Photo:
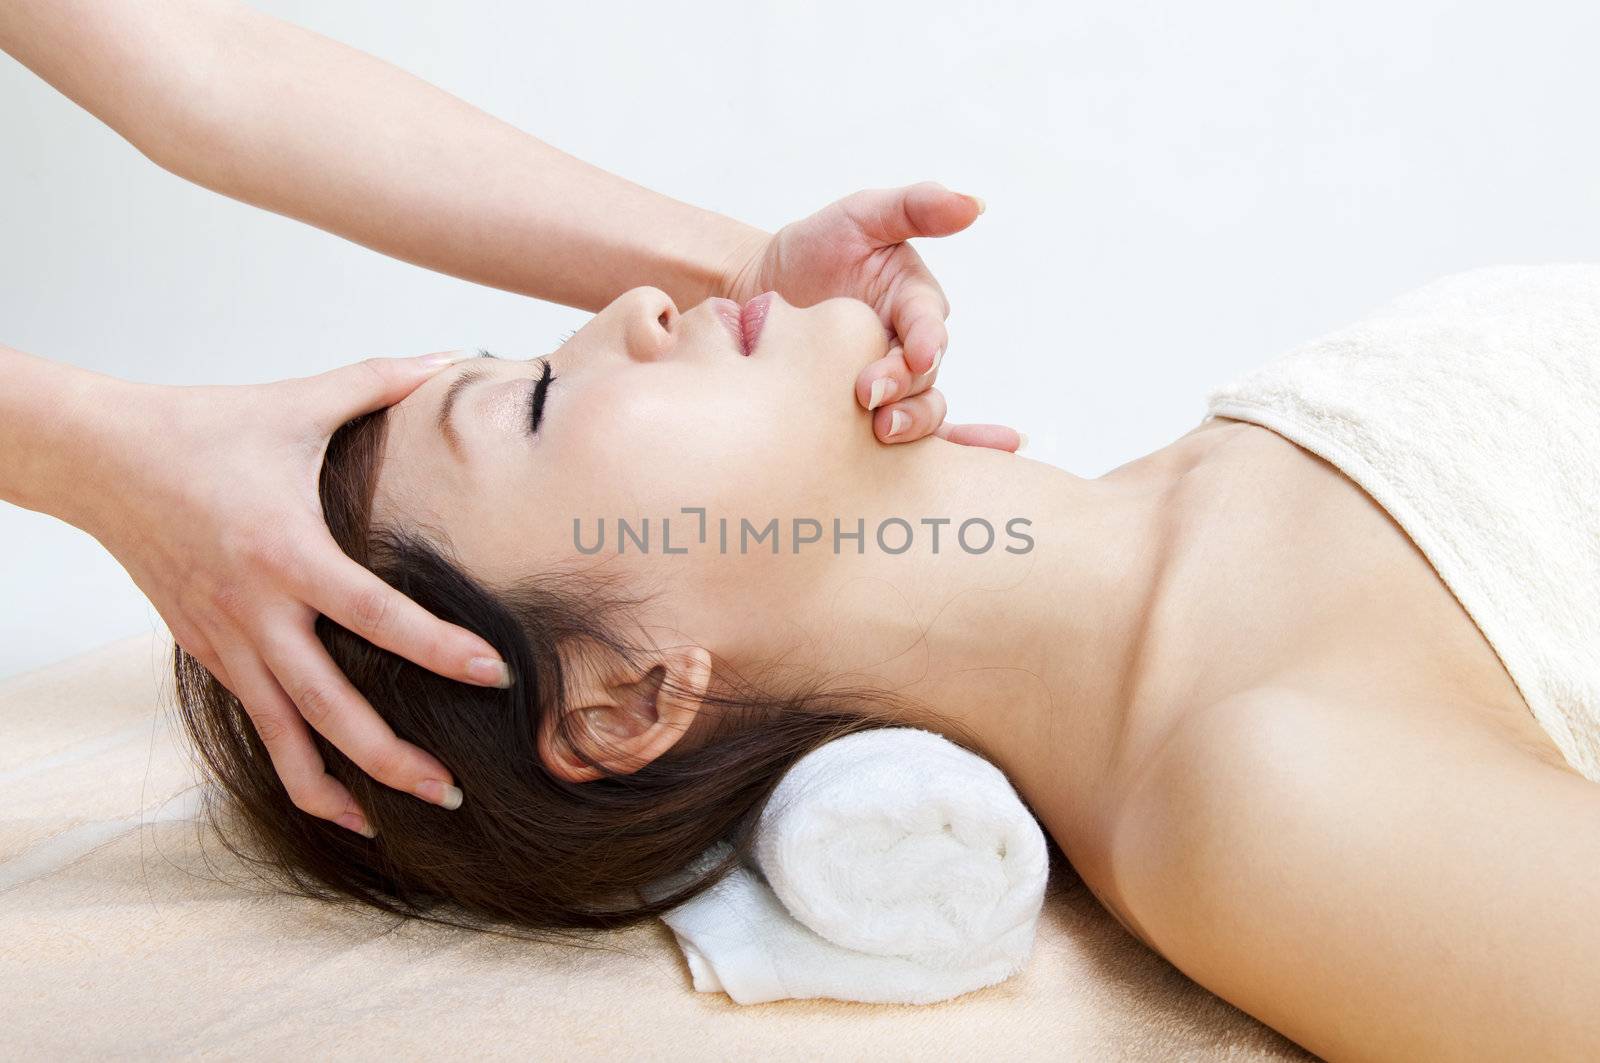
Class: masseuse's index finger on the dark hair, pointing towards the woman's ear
296,541,510,690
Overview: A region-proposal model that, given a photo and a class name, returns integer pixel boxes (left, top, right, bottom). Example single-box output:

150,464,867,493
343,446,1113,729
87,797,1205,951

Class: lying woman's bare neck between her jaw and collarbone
761,422,1206,845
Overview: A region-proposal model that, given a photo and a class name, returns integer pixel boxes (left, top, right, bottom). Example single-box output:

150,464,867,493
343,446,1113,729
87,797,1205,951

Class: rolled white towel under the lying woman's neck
649,728,1050,1004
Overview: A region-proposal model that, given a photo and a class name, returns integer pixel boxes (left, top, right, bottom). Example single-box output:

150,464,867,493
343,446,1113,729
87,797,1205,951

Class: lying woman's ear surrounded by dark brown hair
539,645,710,783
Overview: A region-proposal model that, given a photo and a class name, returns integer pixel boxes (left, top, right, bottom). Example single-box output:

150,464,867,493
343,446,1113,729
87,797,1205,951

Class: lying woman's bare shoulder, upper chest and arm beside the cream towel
1068,419,1600,1058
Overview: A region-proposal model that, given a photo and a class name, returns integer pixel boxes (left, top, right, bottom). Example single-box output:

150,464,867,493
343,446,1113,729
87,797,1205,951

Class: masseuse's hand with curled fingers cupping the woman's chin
723,181,1022,450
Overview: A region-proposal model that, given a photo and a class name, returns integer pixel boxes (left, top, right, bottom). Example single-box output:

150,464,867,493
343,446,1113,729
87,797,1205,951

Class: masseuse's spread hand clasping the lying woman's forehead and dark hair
88,354,507,832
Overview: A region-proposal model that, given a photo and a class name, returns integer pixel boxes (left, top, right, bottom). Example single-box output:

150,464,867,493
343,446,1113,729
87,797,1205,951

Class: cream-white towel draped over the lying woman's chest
1208,263,1600,781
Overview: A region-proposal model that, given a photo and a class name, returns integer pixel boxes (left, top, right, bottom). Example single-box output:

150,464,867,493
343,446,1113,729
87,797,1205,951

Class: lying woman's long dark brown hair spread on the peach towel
174,406,915,937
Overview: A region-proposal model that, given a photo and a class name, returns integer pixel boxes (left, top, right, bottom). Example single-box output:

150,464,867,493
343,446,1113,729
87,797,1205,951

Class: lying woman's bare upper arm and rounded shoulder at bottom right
1115,692,1600,1060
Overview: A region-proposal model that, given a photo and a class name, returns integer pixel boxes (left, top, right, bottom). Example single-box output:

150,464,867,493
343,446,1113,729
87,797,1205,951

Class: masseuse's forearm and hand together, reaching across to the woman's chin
0,0,1019,409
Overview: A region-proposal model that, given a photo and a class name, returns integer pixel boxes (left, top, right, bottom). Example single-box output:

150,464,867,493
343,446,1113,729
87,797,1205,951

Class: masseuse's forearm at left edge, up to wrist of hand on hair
0,347,130,533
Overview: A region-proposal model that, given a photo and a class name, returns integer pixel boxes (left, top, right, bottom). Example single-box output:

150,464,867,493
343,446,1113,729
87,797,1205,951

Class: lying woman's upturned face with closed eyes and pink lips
374,288,888,586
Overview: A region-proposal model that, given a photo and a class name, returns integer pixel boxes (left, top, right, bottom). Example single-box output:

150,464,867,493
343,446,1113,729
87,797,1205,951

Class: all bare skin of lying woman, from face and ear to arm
376,288,1600,1060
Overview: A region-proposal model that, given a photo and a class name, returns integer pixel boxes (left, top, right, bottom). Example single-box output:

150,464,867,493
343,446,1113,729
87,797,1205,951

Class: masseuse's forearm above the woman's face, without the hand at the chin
0,0,763,309
